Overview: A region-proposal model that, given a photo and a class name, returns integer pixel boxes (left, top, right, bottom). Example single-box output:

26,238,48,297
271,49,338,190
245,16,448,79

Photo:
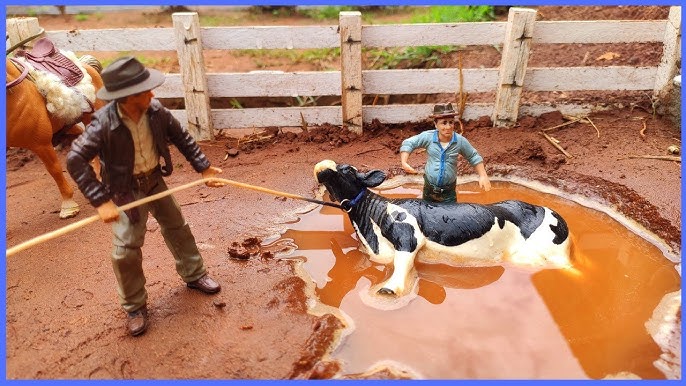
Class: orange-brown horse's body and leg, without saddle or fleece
5,59,105,218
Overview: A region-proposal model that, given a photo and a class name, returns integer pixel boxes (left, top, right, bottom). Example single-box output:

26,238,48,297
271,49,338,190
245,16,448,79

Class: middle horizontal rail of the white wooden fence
155,67,657,98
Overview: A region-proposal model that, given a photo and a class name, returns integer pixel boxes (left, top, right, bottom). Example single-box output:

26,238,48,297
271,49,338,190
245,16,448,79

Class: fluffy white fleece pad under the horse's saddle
16,50,95,123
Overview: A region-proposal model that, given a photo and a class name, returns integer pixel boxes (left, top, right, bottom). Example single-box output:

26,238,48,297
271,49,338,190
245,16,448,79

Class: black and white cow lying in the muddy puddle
314,160,571,295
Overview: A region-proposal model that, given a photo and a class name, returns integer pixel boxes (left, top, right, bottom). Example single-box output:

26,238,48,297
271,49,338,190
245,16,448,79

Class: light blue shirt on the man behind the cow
400,129,483,187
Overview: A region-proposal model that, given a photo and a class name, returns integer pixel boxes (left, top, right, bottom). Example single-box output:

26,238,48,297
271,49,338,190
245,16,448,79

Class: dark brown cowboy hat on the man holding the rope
97,56,165,101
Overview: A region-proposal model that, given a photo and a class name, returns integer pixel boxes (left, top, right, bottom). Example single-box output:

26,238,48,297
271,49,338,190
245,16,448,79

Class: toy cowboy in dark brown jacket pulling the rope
67,57,223,336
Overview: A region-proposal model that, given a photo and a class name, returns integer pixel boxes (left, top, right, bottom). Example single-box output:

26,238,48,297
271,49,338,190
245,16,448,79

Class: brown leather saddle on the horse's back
15,38,83,87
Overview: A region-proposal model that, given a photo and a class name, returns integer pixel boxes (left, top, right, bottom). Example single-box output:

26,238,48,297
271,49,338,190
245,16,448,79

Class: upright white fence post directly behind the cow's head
338,11,362,134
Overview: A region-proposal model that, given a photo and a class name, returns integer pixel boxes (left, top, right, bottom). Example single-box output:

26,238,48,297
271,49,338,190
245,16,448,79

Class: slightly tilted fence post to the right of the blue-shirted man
492,8,536,126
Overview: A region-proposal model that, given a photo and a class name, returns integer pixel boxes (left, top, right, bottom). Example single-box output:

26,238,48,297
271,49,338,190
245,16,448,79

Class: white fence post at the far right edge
653,6,681,96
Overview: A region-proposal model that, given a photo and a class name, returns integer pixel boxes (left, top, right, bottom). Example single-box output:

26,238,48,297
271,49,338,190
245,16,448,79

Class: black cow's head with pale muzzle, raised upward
314,160,386,202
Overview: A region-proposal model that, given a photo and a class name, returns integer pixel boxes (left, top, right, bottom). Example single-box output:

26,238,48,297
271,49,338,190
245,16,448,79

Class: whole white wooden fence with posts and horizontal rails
6,7,681,140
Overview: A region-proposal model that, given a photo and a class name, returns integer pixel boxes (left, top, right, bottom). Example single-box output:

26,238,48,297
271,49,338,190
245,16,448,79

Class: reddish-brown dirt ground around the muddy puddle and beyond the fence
6,7,681,379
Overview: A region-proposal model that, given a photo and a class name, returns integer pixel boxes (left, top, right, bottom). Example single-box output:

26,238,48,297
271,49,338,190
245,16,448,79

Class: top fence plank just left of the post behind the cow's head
202,25,340,50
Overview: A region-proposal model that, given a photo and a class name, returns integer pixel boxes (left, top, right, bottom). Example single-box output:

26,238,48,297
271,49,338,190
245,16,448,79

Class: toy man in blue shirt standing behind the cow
400,103,491,202
